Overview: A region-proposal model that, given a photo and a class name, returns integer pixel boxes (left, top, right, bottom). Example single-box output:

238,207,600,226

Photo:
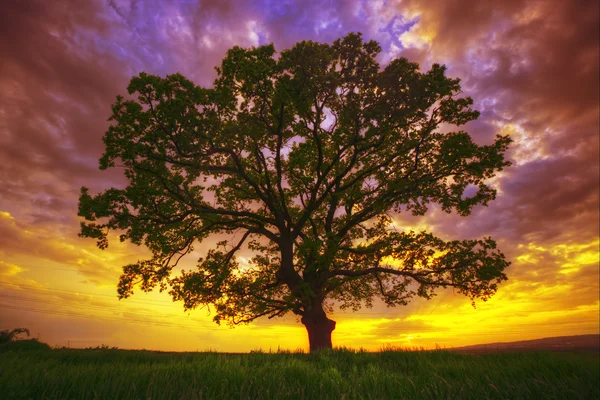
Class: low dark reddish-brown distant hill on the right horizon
448,335,600,353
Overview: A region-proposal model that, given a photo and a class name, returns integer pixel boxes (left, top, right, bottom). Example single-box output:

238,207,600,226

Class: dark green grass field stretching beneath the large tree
0,342,600,400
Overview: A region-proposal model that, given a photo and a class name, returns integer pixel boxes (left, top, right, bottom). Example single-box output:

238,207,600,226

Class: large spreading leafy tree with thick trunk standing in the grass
79,34,510,351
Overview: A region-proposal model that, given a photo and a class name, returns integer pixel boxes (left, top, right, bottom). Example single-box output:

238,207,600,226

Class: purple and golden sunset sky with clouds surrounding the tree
0,0,600,352
